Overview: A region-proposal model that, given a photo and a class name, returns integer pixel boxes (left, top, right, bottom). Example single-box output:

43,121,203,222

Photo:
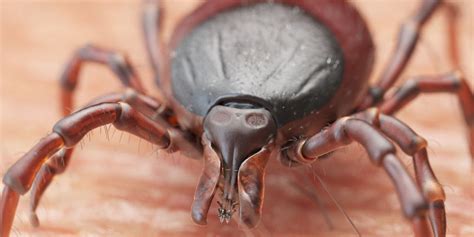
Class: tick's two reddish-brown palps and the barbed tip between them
192,135,270,228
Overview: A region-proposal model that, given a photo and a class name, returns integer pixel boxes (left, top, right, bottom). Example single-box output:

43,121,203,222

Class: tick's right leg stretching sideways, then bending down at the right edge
379,72,474,158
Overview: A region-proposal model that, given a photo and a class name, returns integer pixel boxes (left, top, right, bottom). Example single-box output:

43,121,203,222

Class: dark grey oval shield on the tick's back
172,3,344,126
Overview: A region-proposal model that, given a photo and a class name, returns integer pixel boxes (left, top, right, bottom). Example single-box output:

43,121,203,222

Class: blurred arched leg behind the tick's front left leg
60,45,145,115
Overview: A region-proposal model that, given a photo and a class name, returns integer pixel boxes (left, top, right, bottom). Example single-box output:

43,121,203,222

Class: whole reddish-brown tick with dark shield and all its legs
0,0,474,236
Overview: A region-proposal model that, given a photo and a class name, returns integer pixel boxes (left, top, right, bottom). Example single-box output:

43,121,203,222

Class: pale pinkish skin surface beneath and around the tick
0,0,474,236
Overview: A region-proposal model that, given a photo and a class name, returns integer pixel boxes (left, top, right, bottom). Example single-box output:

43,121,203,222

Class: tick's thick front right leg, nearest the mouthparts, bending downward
282,117,431,237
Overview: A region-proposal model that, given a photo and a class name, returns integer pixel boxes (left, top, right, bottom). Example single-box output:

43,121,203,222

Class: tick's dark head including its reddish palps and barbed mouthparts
193,104,276,227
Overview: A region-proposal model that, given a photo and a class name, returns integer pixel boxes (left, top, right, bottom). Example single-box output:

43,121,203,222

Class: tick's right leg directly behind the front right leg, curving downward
354,108,446,237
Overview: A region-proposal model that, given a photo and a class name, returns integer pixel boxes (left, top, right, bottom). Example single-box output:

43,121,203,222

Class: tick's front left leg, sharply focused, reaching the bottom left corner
0,103,202,237
